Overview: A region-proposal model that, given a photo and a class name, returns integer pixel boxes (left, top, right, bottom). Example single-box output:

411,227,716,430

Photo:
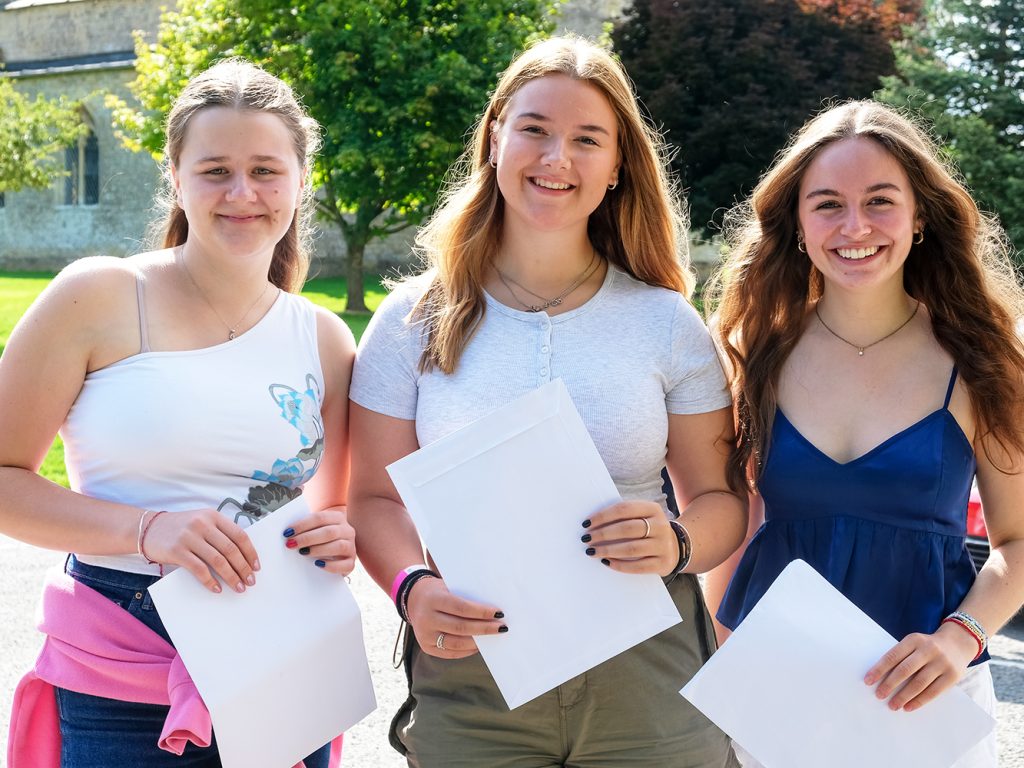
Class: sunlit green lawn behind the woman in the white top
0,272,387,485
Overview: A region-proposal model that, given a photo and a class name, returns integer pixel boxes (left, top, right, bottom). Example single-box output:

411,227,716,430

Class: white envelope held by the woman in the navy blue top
680,560,994,768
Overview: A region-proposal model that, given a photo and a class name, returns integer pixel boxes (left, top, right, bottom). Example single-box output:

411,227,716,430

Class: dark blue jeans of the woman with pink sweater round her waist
56,555,331,768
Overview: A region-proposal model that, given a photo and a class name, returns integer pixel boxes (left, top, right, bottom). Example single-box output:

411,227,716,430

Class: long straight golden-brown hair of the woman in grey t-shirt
413,37,694,374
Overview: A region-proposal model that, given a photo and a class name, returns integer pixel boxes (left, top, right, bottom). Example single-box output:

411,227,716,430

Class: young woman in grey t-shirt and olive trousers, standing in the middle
349,38,746,768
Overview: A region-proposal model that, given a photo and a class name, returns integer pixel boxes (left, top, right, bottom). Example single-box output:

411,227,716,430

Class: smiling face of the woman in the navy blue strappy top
798,138,921,289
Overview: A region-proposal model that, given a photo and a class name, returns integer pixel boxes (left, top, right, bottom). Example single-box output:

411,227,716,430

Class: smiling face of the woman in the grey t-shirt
490,75,620,237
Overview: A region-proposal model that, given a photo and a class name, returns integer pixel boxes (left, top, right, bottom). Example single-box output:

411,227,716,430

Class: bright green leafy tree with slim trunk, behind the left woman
116,0,555,310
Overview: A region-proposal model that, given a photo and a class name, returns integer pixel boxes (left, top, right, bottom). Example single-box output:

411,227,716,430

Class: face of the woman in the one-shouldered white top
172,106,303,261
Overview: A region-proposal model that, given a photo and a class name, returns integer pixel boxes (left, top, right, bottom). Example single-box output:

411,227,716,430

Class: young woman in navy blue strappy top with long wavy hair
711,101,1024,768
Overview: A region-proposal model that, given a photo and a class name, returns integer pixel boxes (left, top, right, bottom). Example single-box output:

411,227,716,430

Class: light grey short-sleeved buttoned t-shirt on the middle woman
350,266,731,518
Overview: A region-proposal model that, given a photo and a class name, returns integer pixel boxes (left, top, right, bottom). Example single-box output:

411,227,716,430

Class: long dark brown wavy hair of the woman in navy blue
708,100,1024,484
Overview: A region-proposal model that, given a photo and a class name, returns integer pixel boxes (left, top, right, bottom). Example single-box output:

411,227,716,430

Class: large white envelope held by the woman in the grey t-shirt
388,379,682,709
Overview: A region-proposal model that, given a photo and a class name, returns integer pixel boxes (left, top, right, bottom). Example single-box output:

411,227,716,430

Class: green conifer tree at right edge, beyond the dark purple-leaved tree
878,0,1024,251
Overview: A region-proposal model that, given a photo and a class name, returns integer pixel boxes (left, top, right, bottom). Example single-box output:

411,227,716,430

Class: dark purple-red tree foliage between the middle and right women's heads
612,0,919,230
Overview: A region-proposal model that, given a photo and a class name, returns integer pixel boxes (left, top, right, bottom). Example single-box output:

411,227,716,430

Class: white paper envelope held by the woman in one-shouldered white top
150,497,377,768
